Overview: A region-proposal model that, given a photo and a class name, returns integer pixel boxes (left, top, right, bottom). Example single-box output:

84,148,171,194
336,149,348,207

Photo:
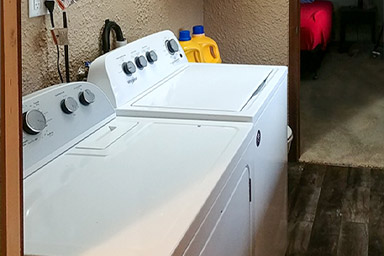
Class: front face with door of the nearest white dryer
183,164,252,256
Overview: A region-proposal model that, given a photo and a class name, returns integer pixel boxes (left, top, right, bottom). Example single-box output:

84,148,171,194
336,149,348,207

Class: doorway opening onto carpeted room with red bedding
297,0,384,168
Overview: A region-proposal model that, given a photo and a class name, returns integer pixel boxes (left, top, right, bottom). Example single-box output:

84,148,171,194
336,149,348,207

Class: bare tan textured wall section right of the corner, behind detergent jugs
204,0,289,65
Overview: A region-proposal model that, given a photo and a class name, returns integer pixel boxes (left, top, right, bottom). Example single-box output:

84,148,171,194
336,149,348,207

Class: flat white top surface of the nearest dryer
24,118,252,256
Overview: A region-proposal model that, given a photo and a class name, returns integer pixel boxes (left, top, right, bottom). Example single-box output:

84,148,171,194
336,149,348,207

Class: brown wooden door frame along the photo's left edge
0,0,23,256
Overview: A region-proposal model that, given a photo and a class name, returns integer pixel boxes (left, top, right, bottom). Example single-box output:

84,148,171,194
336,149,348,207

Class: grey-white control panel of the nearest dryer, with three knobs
23,82,115,178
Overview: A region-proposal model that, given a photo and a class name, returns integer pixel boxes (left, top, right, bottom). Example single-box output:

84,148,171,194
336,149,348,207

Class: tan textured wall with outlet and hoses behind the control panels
21,0,203,95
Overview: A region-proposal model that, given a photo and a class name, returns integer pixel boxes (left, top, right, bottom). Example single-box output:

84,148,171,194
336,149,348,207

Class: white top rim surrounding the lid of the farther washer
116,66,287,123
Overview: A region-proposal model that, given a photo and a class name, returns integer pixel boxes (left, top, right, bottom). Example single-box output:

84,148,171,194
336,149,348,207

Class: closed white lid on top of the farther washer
132,64,273,112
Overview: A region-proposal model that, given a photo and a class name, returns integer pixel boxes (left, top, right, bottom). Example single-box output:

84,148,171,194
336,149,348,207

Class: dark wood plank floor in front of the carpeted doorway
286,164,384,256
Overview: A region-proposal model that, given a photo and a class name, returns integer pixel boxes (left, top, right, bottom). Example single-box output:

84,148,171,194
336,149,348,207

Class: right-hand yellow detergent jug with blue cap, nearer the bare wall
192,25,221,63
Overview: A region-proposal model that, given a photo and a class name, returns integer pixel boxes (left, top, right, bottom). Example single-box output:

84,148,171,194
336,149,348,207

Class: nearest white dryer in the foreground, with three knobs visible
23,82,254,256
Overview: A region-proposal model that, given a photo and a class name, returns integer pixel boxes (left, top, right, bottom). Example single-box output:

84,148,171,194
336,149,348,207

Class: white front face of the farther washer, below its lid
252,78,288,256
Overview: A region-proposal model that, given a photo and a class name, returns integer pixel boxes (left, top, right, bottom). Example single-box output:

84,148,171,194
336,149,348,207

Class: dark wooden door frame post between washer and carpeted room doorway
288,0,301,162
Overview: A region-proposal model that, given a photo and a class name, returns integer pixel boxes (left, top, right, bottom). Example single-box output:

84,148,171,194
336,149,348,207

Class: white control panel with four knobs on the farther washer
88,31,188,107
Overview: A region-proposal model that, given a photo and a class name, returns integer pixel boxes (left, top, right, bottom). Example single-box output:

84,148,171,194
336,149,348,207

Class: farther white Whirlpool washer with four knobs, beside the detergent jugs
88,31,287,256
